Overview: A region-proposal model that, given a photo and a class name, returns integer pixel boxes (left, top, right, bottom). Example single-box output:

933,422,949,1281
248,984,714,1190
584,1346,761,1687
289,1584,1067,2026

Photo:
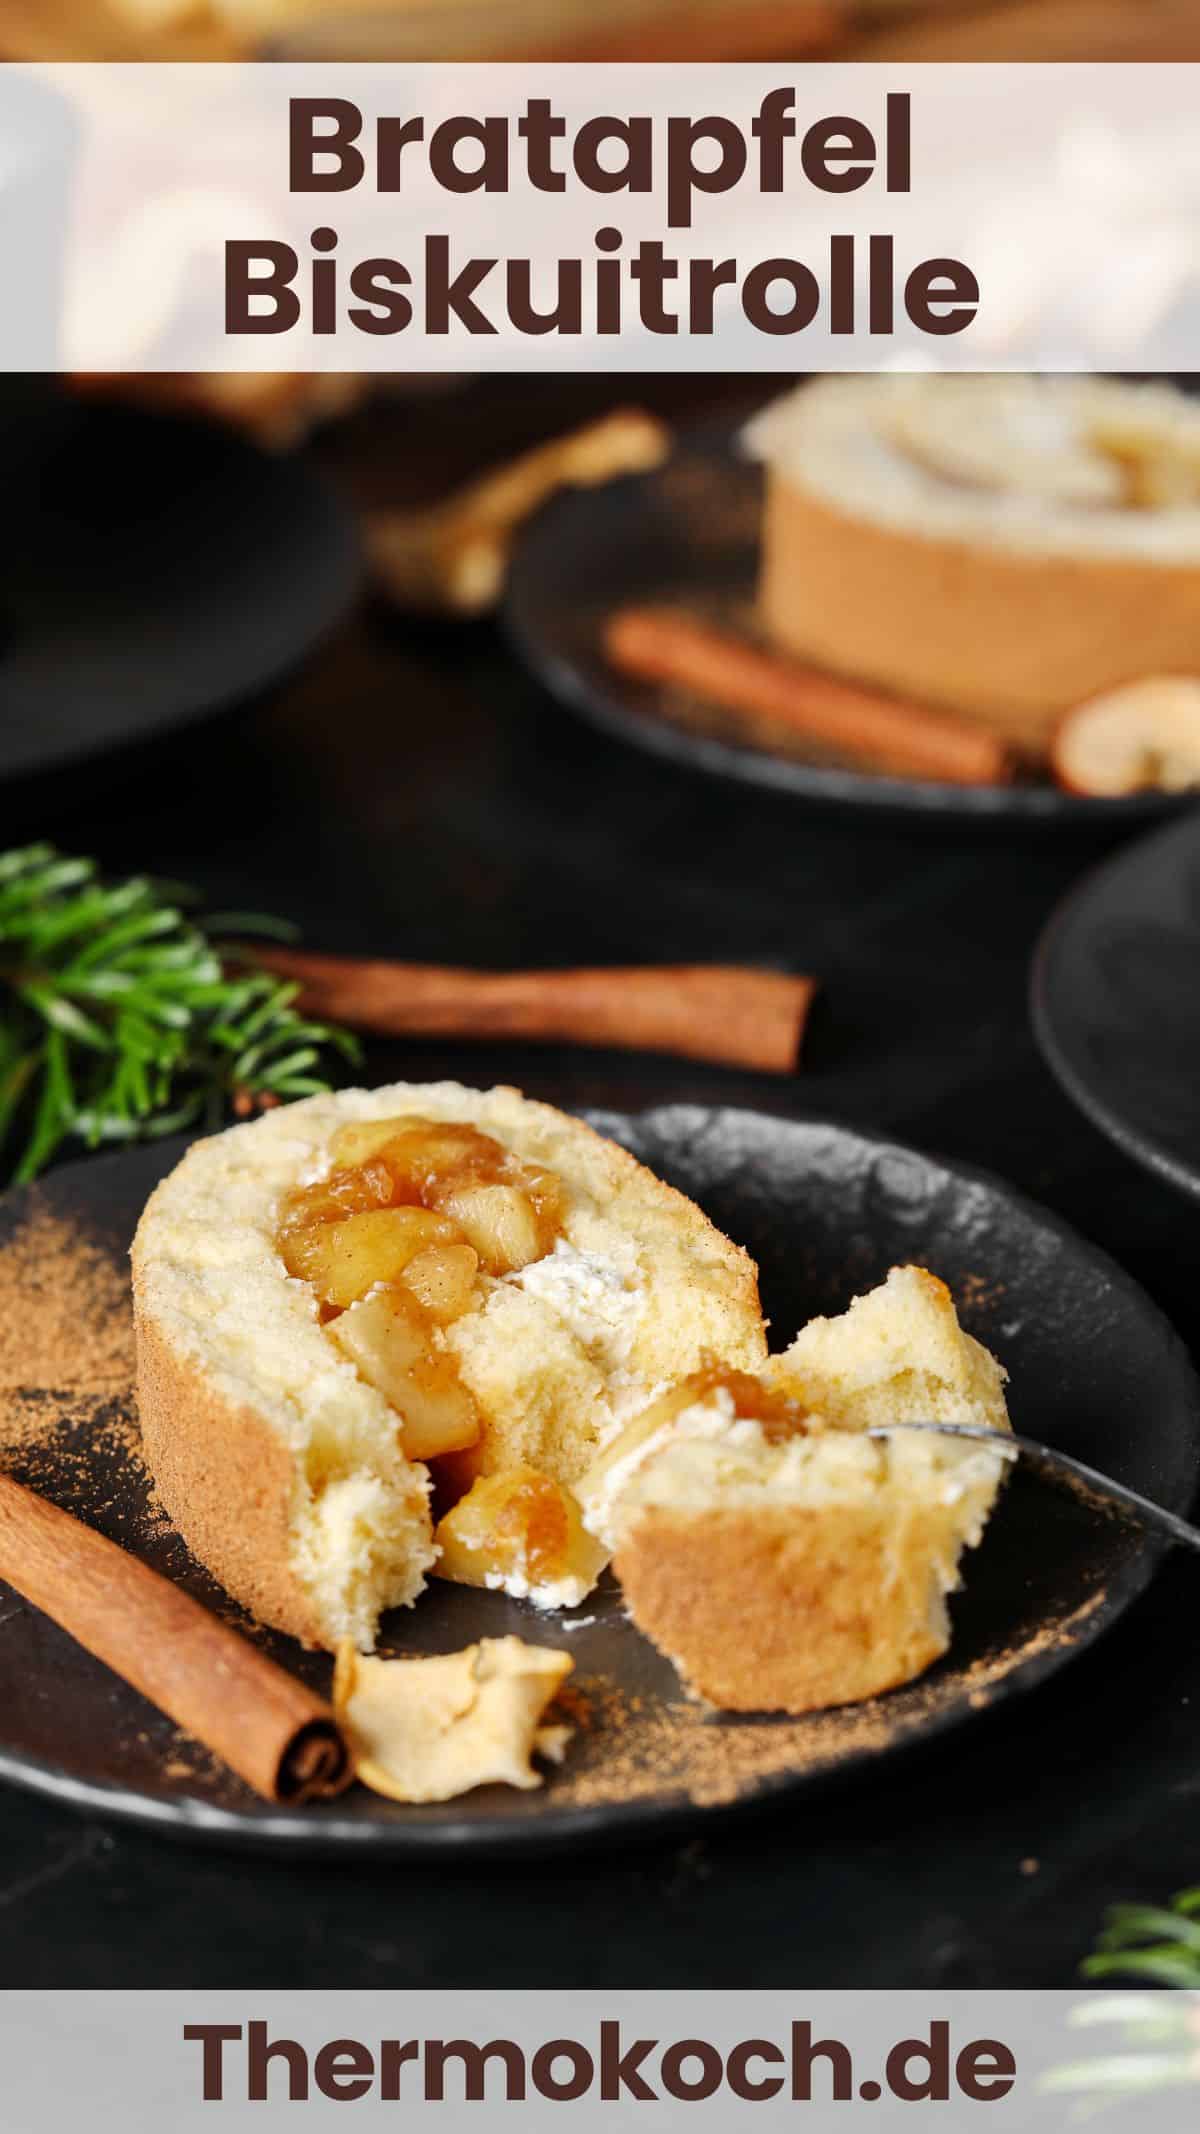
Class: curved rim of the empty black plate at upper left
0,403,363,790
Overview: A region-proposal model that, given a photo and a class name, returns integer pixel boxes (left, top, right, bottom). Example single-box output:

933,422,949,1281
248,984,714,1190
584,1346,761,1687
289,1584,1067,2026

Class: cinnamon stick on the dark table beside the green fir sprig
254,947,816,1073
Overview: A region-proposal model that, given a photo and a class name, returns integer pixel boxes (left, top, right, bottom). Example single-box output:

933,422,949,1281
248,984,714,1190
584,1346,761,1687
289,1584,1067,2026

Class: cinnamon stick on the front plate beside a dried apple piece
0,1475,352,1801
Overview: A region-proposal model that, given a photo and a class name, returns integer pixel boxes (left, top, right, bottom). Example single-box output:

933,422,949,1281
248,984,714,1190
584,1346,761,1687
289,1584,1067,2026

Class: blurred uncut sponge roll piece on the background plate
747,376,1200,749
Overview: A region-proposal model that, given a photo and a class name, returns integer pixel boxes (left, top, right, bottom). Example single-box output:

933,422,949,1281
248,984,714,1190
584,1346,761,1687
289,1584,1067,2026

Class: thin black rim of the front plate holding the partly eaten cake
0,1103,1200,1859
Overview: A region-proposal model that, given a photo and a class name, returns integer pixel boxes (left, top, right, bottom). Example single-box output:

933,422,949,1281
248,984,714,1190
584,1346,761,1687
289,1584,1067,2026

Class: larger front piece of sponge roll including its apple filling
132,1082,767,1650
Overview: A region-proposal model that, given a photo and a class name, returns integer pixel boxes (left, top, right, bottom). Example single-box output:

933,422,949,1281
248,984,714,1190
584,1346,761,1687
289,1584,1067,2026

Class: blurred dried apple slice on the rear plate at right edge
1051,674,1200,798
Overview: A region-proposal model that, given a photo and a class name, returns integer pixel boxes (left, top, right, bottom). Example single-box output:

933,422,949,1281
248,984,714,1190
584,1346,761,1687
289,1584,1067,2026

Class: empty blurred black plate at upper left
0,408,359,777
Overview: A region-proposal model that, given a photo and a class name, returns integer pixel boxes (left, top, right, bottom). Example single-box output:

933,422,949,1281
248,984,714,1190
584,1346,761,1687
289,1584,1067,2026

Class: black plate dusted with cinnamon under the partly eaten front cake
0,1105,1200,1852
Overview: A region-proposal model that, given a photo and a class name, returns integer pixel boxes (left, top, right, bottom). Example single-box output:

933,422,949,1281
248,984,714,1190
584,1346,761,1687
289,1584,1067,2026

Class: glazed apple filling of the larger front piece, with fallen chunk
278,1118,604,1598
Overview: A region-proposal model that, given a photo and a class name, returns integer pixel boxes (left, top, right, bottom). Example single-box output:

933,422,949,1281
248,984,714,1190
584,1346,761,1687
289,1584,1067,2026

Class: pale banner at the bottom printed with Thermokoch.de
0,1988,1200,2134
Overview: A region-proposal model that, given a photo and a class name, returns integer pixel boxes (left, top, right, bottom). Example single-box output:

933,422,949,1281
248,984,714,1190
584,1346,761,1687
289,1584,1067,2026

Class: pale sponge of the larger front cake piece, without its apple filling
132,1082,767,1650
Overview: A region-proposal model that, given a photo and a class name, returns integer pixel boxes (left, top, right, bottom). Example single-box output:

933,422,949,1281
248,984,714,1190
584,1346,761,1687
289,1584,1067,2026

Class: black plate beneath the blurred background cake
504,440,1177,826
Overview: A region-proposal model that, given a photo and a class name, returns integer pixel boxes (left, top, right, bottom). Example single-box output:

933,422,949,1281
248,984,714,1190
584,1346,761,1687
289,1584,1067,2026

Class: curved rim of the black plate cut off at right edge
1029,802,1200,1199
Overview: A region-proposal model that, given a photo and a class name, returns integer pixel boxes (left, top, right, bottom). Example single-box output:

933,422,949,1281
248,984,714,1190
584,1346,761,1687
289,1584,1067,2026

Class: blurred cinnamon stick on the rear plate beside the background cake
604,608,1012,785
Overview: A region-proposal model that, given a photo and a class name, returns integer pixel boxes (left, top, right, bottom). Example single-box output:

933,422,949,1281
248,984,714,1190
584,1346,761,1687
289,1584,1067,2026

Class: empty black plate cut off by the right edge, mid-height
1033,811,1200,1193
